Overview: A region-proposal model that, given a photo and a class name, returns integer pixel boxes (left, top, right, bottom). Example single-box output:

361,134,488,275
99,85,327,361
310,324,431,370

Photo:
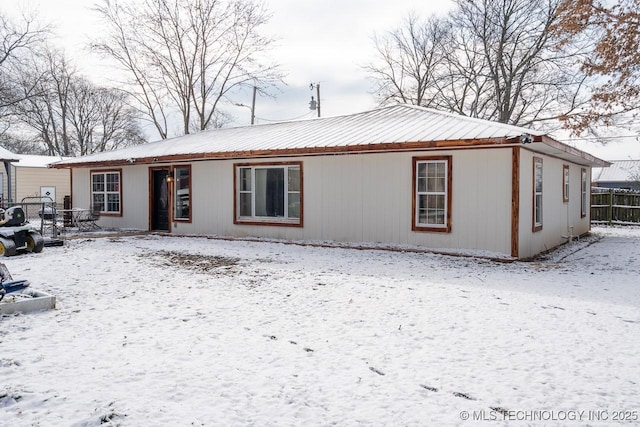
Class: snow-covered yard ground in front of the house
0,228,640,426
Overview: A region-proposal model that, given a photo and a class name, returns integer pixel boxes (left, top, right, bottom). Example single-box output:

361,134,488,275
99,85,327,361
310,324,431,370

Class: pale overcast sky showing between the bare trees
0,0,640,160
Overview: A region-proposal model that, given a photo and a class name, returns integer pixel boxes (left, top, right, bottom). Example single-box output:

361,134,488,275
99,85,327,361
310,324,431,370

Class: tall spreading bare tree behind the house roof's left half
93,0,281,138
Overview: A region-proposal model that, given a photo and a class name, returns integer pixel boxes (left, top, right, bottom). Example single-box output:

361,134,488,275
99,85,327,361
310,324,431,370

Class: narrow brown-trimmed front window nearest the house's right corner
413,156,451,232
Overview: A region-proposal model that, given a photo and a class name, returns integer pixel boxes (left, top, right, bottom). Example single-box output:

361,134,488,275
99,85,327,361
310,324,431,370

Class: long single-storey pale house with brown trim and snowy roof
53,105,608,258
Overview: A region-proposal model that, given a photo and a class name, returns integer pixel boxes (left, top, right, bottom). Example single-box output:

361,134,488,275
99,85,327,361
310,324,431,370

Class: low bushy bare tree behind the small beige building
14,50,144,156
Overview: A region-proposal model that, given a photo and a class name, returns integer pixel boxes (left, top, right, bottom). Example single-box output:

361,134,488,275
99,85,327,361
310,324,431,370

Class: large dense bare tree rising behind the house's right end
453,0,585,125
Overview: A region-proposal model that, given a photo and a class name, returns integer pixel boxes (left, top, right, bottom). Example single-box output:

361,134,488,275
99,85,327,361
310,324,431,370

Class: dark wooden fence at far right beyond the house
591,187,640,224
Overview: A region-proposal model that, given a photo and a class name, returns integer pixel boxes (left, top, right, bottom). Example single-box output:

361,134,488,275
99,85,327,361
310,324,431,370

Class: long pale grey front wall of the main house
73,148,511,254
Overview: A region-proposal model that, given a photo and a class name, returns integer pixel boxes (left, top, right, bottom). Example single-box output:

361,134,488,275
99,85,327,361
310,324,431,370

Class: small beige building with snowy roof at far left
0,147,71,207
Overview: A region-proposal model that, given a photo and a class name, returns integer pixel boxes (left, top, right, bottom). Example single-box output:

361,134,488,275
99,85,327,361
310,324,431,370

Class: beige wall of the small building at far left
0,166,71,206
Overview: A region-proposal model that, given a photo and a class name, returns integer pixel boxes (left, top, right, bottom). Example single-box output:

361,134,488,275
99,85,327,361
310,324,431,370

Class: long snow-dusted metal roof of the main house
54,105,607,167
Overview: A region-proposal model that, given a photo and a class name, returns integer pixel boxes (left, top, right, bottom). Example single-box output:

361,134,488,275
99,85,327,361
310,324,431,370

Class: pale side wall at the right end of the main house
518,149,591,258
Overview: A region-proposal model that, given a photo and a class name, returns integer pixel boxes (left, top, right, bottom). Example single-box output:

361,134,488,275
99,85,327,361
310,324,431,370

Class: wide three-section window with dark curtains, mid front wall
235,162,302,226
